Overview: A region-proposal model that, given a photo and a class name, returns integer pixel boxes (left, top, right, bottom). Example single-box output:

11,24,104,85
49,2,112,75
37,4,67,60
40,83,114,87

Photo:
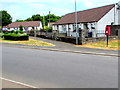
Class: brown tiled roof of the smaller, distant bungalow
8,21,40,28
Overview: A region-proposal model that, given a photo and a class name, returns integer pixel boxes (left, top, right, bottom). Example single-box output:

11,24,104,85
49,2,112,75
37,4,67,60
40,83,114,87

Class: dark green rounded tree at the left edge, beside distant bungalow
0,10,12,26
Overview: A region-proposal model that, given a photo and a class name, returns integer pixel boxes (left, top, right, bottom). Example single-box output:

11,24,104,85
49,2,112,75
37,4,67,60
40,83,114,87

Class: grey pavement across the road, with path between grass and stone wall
2,37,120,57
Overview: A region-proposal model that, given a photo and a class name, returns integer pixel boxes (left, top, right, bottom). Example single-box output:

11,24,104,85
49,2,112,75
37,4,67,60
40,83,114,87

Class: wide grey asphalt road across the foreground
2,46,118,88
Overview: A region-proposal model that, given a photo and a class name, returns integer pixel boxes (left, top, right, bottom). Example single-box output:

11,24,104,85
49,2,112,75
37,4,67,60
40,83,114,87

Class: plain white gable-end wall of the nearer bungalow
96,8,114,37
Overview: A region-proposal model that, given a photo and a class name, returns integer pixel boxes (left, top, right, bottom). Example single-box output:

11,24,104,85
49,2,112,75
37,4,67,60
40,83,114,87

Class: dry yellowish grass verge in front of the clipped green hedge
0,38,55,46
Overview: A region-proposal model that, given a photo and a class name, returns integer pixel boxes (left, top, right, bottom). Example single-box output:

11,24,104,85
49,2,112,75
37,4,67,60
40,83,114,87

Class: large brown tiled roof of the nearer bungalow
55,4,115,24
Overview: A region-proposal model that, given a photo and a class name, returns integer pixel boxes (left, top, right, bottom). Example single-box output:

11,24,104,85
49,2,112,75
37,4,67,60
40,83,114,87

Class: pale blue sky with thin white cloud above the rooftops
0,0,119,22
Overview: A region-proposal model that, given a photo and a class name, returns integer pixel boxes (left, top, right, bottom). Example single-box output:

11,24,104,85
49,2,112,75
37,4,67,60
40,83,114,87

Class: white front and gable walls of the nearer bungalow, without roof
54,7,116,37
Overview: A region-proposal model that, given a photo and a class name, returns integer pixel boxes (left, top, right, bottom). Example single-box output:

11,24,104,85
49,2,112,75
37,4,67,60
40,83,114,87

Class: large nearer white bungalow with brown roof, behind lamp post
53,4,120,37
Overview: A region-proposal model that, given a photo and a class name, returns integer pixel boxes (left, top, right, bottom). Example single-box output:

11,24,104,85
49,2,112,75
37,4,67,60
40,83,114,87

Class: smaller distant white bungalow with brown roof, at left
7,21,42,31
